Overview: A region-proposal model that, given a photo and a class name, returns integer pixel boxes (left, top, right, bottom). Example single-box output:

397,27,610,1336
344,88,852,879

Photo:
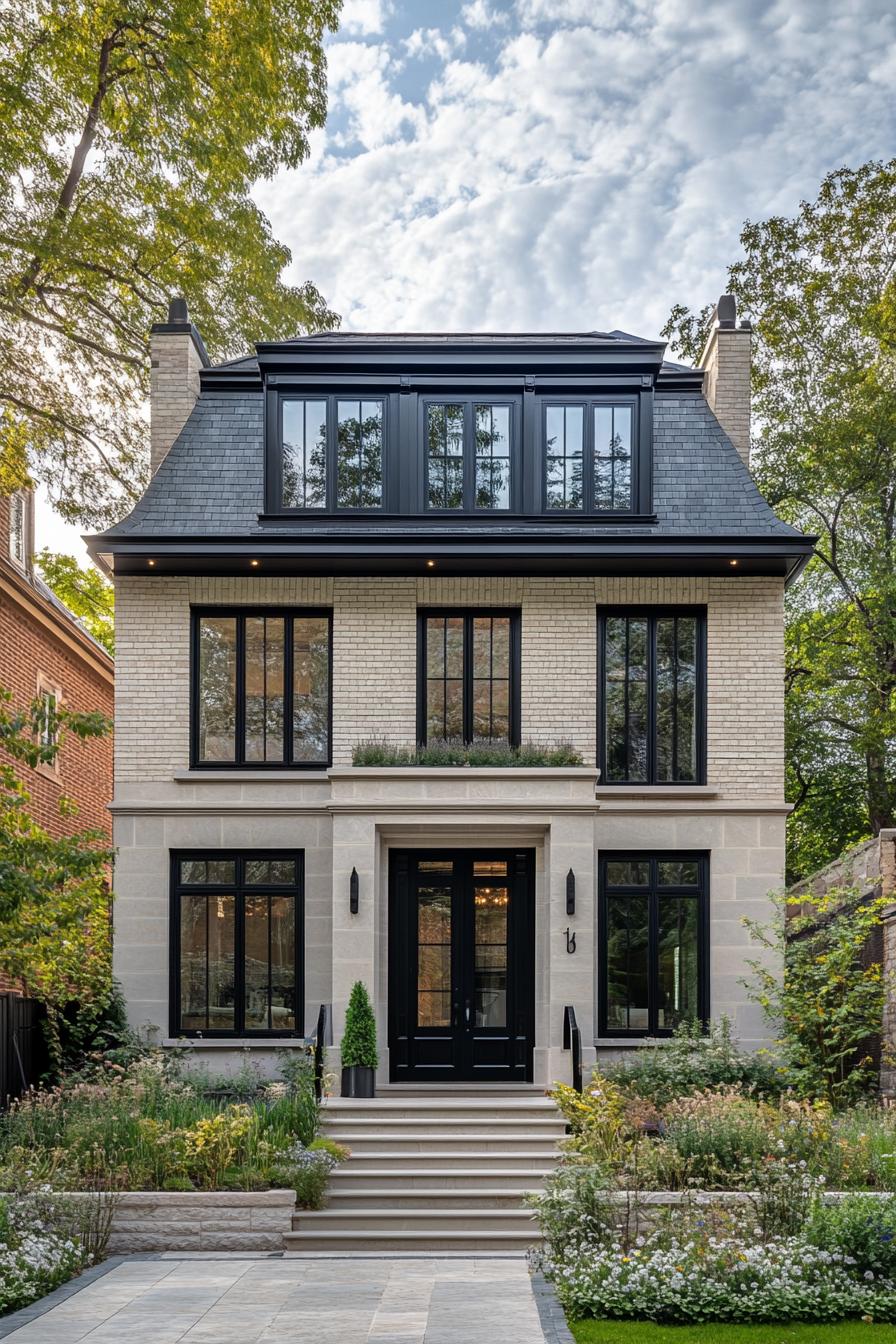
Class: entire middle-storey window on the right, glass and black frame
598,607,707,784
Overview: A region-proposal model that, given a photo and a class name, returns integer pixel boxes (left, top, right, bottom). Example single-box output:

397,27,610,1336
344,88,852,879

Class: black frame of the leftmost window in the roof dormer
266,383,398,519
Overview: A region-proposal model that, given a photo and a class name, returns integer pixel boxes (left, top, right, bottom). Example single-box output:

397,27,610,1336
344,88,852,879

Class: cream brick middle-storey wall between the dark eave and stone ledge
116,577,783,800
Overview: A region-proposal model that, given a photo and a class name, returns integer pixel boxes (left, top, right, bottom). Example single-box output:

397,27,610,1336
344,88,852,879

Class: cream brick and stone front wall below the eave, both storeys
113,577,786,1082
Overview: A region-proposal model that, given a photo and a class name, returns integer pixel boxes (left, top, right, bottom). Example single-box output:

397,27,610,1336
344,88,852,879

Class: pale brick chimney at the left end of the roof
149,298,208,476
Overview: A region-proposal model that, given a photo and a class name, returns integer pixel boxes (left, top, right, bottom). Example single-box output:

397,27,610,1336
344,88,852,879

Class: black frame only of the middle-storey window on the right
598,603,707,789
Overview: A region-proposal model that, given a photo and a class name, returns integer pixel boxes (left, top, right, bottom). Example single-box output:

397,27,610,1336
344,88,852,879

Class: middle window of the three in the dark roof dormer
424,398,514,512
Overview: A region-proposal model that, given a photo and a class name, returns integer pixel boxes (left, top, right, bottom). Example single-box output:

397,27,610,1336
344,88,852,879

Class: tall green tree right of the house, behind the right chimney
664,160,896,876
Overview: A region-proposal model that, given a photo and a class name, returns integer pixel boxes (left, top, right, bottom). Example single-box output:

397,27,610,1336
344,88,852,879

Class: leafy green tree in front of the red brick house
0,688,113,1067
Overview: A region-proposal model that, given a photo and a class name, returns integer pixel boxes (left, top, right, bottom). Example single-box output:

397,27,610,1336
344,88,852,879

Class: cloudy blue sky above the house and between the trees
39,0,896,552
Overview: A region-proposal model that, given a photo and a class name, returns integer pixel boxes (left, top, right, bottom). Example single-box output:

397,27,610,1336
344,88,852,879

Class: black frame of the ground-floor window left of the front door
168,848,305,1040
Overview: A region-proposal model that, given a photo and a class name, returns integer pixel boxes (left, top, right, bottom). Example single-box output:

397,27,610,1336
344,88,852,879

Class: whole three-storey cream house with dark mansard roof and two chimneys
91,300,811,1083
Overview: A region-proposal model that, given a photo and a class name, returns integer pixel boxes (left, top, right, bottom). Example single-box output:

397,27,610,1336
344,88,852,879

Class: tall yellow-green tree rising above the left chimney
0,0,341,527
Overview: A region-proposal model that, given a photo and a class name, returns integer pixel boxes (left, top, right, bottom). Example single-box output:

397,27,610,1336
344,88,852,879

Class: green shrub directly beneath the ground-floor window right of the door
606,1017,782,1106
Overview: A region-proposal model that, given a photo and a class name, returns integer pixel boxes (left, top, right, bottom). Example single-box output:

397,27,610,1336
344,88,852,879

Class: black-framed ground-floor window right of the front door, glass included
599,852,709,1036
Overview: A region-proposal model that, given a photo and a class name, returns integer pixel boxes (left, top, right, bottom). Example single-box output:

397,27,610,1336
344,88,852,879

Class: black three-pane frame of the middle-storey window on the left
189,605,333,771
